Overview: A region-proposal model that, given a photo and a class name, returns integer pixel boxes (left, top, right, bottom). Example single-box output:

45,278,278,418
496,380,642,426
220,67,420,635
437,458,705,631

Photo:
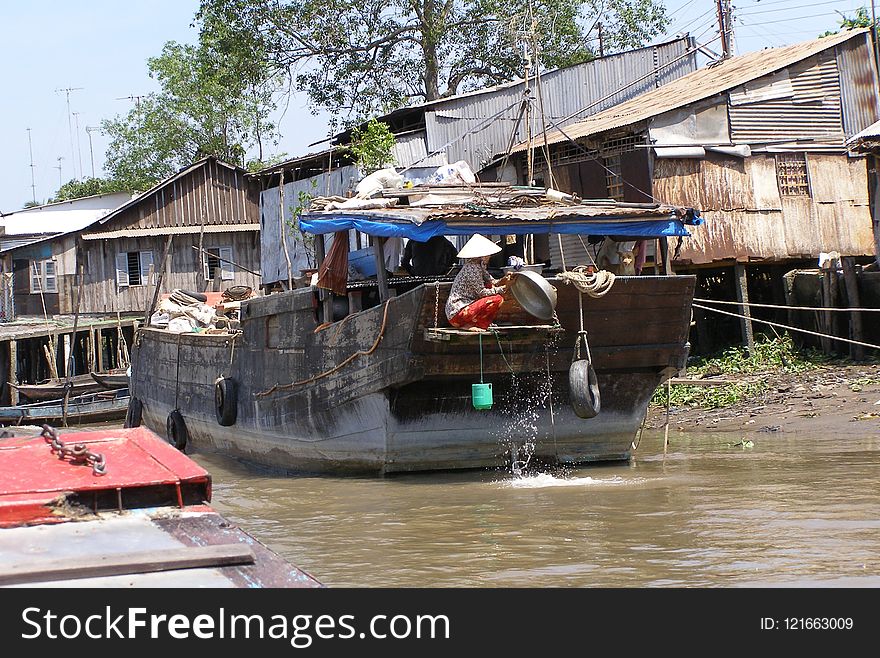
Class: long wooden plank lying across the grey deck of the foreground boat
0,544,254,586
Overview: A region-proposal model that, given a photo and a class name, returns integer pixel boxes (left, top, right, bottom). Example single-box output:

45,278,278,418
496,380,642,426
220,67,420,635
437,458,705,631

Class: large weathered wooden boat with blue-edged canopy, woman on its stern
126,187,698,474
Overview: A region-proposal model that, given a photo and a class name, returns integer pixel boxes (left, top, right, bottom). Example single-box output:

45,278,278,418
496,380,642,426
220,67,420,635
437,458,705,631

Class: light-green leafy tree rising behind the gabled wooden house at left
102,36,275,190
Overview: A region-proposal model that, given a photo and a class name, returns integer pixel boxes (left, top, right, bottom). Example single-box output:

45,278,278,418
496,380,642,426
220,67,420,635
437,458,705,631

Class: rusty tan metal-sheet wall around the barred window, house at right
654,153,873,264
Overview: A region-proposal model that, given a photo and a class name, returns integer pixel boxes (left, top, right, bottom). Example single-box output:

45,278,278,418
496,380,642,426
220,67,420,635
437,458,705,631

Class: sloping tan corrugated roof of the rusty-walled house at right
512,29,867,153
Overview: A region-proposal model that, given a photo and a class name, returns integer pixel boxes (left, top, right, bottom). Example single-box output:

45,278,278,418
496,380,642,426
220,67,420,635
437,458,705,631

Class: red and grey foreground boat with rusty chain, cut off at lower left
0,428,321,588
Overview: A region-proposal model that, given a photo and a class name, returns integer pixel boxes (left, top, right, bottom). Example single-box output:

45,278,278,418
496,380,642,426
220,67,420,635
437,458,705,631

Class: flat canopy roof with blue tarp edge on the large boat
300,204,702,242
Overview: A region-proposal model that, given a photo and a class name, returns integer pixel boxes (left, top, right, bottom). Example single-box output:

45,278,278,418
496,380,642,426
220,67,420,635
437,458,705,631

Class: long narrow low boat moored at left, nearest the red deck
0,388,130,425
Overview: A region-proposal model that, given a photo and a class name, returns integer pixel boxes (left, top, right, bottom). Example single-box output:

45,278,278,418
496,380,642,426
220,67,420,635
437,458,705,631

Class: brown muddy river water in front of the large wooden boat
194,433,880,587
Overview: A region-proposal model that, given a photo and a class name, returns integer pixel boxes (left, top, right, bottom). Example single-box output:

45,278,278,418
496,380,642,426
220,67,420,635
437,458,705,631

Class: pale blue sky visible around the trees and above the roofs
0,0,880,212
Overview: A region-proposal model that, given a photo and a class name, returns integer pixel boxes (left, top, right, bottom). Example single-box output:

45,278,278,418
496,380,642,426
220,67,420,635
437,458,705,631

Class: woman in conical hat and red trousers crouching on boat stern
446,234,508,331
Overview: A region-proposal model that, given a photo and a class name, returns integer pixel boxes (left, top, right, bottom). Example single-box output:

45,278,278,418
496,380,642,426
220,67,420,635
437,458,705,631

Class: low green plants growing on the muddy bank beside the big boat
651,334,830,409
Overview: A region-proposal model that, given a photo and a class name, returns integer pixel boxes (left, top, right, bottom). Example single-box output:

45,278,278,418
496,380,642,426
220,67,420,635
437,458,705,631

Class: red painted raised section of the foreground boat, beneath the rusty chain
0,427,211,527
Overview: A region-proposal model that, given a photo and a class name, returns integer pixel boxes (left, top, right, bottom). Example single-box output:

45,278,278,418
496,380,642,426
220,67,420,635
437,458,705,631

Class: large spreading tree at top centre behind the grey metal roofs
196,0,668,125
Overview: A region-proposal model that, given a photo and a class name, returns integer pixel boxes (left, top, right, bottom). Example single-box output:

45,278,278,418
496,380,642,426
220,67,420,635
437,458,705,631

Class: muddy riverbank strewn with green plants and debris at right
645,335,880,434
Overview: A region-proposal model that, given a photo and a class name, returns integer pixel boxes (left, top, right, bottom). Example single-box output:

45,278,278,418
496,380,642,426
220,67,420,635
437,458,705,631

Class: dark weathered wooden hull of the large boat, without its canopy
132,277,693,475
